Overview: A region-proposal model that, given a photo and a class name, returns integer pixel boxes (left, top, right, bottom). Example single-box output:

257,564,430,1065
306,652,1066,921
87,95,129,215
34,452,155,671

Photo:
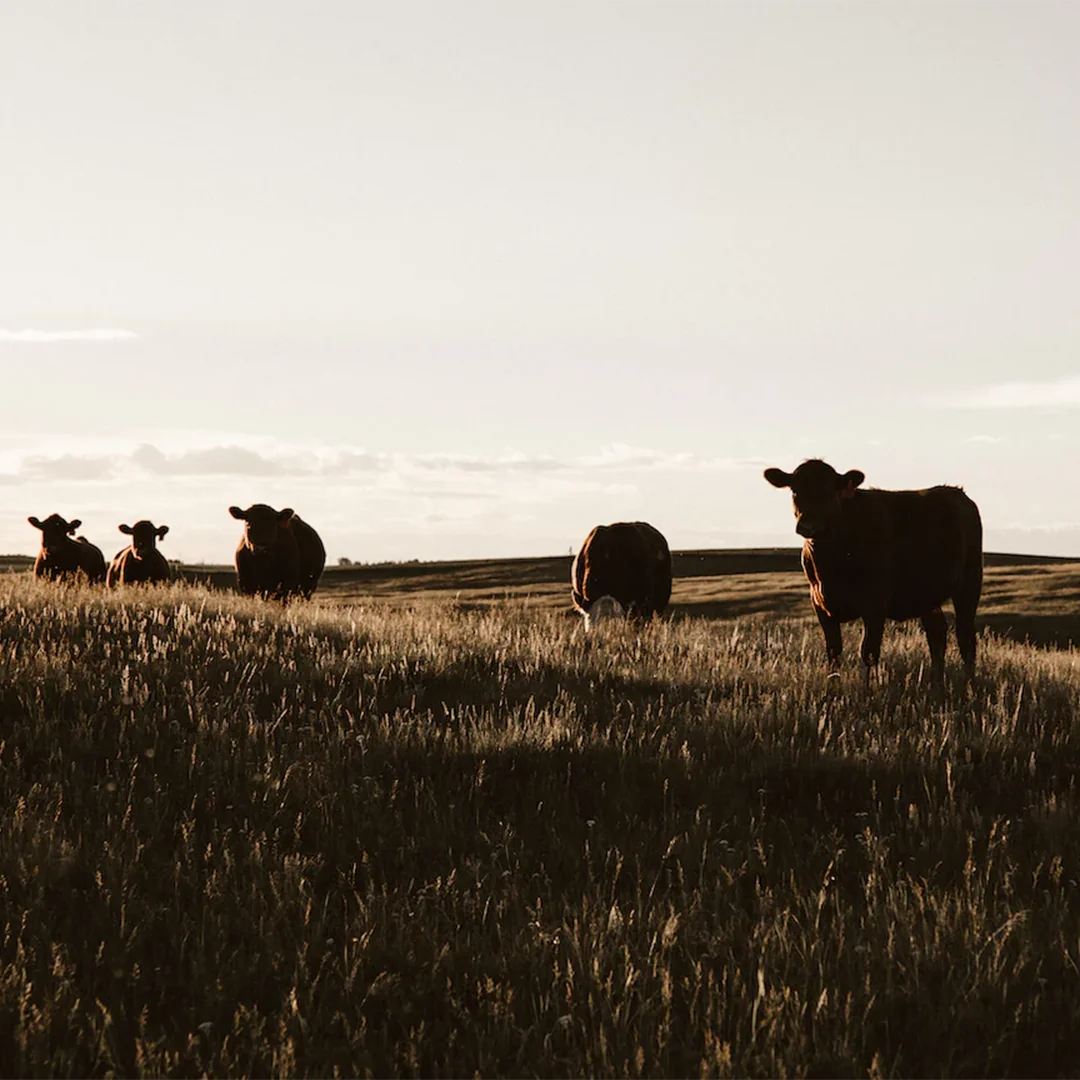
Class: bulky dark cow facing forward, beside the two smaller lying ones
229,502,326,599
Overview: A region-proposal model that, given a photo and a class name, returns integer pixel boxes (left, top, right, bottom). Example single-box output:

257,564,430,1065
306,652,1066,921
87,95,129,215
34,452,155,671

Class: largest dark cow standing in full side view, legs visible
765,460,983,681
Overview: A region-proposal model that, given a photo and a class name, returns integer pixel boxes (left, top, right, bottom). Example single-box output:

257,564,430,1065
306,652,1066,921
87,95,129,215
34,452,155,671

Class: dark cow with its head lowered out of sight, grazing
570,522,672,630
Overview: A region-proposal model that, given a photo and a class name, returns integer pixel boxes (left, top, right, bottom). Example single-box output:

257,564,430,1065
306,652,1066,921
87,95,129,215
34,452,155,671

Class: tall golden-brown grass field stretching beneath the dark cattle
0,555,1080,1080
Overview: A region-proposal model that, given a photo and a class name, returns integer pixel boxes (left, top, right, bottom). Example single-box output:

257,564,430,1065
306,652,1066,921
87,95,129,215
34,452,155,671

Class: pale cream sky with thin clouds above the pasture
0,0,1080,562
